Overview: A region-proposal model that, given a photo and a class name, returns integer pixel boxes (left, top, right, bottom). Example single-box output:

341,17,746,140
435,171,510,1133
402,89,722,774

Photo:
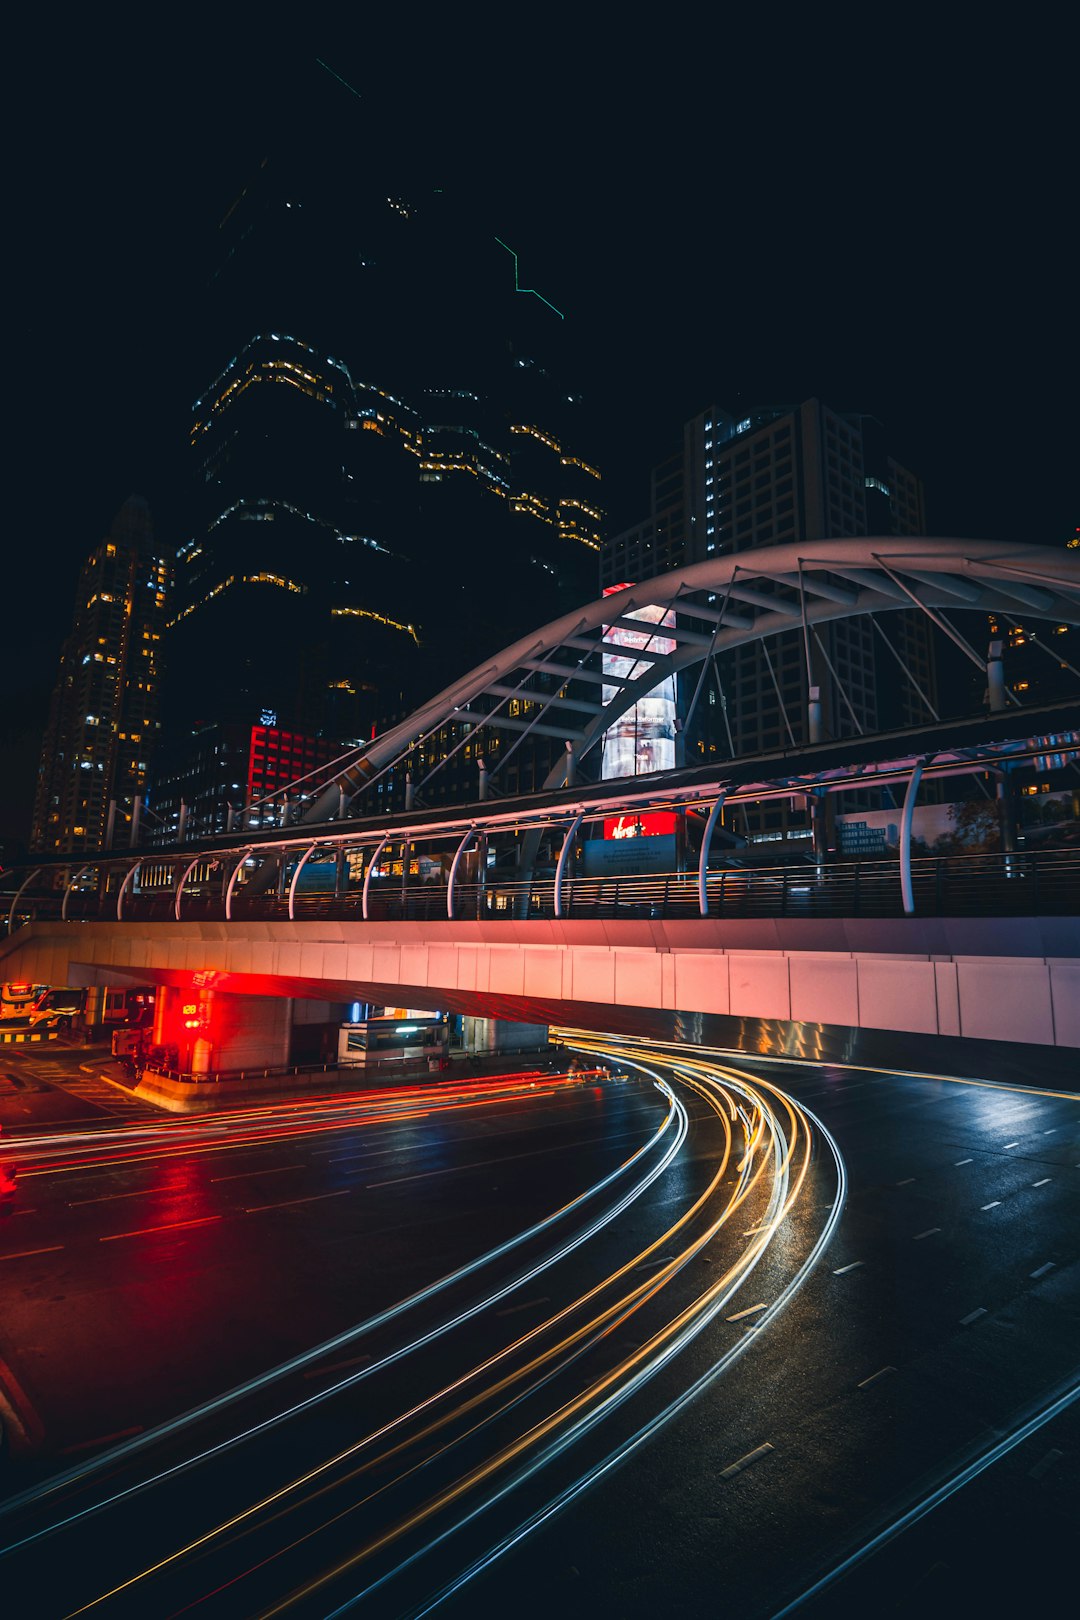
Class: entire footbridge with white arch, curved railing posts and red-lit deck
8,538,1080,1095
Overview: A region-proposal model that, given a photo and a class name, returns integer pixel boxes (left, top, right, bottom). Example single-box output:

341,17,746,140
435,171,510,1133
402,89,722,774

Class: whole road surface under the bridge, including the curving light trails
0,1043,1080,1617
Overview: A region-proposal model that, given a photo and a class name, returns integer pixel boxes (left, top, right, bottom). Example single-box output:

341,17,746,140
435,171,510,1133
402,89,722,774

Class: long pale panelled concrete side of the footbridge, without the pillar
0,917,1080,1048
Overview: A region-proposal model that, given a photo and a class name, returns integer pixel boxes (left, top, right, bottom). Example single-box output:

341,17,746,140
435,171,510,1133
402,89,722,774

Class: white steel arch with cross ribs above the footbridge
303,536,1080,823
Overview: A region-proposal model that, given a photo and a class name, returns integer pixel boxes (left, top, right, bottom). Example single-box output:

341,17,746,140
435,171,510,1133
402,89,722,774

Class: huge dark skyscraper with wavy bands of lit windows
155,162,601,829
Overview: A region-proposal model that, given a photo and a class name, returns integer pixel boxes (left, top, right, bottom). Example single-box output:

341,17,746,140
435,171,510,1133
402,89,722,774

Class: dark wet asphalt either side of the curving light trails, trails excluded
0,1059,1080,1617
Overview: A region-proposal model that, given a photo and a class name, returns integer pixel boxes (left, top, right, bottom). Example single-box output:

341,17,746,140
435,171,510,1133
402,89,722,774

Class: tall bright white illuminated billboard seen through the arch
601,585,675,784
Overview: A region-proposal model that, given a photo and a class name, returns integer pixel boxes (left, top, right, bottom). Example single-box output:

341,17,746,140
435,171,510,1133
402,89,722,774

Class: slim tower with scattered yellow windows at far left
31,496,170,855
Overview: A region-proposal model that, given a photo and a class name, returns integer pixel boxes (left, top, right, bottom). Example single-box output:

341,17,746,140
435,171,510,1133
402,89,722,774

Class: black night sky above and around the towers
0,19,1080,834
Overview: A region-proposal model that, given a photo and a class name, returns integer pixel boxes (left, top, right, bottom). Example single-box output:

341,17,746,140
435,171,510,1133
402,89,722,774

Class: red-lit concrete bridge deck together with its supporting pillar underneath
0,917,1080,1084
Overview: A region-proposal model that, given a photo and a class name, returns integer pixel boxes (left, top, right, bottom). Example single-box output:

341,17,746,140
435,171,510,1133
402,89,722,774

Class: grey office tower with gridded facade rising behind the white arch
601,400,934,838
